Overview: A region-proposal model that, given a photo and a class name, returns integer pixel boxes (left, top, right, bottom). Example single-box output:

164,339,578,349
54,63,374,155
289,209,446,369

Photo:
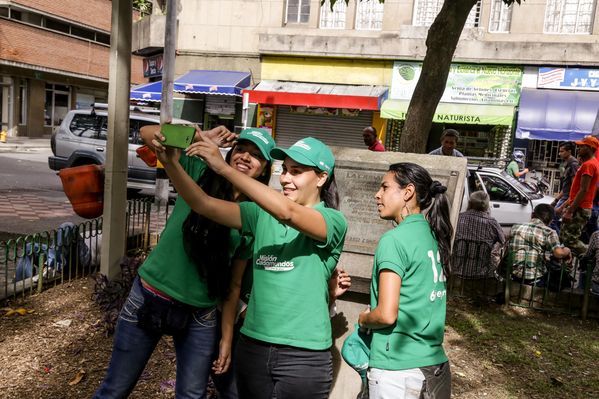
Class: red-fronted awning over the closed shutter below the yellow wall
243,80,388,111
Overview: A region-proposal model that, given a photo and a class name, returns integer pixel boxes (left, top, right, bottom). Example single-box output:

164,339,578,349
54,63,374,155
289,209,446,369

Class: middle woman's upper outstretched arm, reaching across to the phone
185,140,327,241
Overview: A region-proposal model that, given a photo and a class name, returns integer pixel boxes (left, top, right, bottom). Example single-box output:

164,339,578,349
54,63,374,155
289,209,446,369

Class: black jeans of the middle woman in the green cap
235,335,333,399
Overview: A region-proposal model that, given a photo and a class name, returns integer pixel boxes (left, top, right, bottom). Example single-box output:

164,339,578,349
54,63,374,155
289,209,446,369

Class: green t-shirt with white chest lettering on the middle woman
240,202,347,350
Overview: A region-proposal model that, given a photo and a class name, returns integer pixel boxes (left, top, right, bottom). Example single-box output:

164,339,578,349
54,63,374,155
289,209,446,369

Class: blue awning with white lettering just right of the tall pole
174,70,252,96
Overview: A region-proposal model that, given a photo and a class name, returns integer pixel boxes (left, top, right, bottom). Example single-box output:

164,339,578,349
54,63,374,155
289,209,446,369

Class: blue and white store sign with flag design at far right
537,67,599,91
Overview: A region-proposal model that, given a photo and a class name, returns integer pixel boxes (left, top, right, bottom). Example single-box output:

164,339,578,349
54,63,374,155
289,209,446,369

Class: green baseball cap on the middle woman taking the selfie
270,137,335,176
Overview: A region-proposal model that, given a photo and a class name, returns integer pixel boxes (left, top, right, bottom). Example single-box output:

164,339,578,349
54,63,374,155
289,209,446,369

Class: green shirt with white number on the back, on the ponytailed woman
369,214,447,370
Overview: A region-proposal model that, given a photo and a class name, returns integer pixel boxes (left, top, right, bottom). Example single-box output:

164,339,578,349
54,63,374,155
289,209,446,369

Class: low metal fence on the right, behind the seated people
448,241,599,319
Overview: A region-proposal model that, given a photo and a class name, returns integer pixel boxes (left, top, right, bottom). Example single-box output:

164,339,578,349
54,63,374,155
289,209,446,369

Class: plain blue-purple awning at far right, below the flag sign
516,89,599,141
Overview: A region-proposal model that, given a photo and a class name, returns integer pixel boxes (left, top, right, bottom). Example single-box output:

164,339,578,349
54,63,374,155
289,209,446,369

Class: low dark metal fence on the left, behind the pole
0,199,170,300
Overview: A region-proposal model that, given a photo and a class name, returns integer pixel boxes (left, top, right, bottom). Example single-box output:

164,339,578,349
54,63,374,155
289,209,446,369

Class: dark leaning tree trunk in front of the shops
399,0,477,153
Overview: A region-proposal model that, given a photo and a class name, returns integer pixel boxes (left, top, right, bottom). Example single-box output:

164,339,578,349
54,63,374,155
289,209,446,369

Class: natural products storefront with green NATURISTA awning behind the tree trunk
381,61,522,158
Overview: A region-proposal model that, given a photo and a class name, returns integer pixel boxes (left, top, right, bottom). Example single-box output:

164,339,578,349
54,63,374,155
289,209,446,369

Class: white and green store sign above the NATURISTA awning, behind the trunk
389,61,522,105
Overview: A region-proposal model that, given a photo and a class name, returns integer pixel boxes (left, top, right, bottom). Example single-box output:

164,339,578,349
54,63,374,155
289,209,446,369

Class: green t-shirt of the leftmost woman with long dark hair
139,154,242,308
